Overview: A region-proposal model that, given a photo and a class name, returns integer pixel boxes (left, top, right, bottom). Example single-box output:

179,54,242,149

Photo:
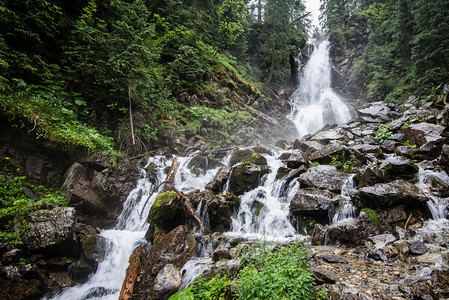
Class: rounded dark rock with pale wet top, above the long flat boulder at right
379,155,419,182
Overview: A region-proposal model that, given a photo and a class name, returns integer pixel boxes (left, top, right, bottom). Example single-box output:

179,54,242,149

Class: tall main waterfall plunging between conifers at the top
289,40,354,137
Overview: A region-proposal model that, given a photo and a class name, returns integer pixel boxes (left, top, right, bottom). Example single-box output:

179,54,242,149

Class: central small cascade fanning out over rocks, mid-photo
229,153,299,239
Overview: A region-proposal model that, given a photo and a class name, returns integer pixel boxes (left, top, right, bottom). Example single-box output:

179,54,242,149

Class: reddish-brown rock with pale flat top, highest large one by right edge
403,123,445,147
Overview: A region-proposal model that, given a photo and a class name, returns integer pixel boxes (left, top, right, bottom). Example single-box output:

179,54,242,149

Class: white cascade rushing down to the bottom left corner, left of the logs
44,156,170,300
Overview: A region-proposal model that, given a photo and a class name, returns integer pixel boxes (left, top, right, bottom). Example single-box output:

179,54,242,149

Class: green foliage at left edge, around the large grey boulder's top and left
0,172,67,245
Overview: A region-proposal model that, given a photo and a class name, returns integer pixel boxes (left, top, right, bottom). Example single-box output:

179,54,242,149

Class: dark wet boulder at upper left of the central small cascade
229,164,270,195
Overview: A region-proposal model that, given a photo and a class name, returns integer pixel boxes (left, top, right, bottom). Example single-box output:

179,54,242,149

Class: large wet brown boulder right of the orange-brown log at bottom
133,226,198,299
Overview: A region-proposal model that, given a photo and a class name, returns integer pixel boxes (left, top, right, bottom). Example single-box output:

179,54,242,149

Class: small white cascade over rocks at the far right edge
416,168,449,222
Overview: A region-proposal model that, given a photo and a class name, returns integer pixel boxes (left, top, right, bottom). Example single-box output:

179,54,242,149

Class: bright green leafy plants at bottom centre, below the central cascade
187,242,320,299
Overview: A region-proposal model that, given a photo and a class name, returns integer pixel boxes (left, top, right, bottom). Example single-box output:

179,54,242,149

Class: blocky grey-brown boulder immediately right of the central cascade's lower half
290,189,336,222
